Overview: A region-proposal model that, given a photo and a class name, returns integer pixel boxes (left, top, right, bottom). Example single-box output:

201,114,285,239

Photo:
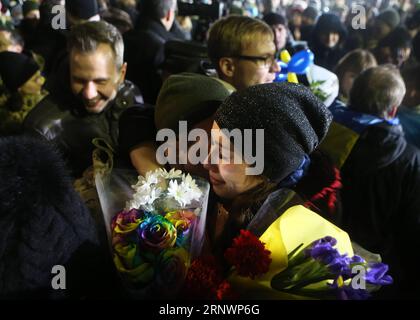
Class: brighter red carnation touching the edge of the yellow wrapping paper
225,230,271,279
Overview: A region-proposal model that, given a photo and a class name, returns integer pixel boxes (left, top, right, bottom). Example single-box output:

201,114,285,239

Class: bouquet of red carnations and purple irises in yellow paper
185,206,392,300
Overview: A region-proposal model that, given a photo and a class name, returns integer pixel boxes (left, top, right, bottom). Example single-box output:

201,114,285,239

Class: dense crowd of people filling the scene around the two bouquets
0,0,420,299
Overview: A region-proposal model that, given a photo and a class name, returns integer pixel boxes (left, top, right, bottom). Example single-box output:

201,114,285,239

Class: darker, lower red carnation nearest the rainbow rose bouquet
184,256,222,299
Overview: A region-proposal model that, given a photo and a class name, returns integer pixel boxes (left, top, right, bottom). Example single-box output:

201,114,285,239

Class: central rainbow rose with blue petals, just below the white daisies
137,215,177,253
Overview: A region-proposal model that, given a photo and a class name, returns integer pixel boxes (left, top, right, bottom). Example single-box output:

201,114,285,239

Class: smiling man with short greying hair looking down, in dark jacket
24,21,141,176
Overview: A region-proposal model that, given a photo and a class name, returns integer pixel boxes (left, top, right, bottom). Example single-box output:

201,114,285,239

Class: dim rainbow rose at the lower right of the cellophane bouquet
155,248,188,297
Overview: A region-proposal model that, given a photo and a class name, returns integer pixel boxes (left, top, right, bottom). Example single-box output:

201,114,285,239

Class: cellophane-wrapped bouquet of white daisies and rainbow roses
95,169,209,299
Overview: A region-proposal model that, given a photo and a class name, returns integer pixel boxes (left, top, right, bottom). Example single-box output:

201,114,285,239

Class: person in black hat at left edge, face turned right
0,51,46,135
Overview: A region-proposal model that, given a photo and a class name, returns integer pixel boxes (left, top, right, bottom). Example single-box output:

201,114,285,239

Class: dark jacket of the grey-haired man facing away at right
342,123,420,298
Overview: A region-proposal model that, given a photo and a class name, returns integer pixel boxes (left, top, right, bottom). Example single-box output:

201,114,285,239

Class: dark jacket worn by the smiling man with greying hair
24,81,141,176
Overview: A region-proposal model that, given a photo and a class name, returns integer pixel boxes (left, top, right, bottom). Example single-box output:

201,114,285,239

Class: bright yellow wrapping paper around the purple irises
229,205,354,300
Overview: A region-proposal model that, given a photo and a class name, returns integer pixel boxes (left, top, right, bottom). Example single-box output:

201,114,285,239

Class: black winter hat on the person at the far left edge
0,51,39,92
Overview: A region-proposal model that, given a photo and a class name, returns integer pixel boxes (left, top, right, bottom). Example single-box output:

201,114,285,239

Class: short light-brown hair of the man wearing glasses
207,15,274,68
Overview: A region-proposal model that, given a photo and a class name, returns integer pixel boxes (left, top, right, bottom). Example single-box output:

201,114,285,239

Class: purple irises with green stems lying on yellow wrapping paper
271,236,393,300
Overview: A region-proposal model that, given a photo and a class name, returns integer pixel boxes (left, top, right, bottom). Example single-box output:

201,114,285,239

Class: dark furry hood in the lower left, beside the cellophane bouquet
0,136,97,297
